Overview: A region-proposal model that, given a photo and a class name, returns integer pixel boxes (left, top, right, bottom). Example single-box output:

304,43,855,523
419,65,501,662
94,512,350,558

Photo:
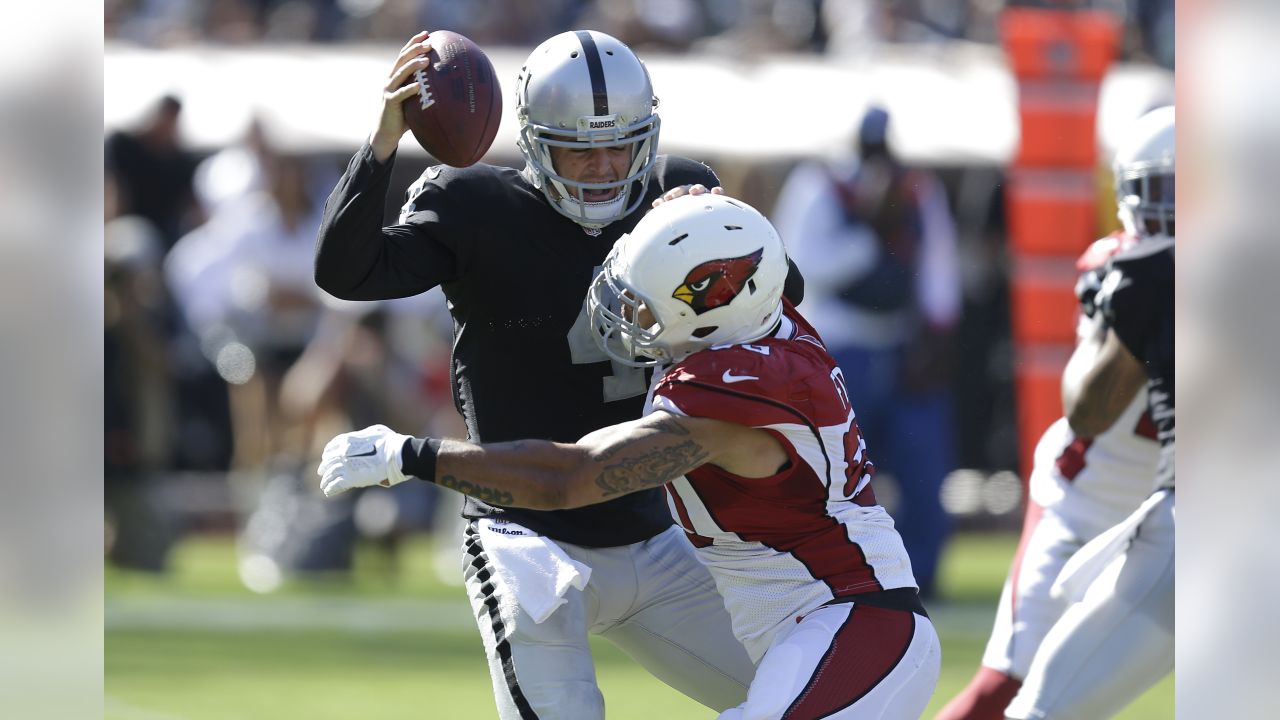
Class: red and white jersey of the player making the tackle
650,304,915,659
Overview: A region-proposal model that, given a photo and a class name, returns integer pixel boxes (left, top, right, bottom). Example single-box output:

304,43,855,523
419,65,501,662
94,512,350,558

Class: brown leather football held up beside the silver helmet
402,29,502,168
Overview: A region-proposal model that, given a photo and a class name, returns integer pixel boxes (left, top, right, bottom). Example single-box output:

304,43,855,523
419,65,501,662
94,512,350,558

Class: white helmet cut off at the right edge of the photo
1114,105,1175,237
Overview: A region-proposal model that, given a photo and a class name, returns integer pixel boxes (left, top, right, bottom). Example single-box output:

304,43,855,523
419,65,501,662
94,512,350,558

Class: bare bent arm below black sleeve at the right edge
1062,316,1147,437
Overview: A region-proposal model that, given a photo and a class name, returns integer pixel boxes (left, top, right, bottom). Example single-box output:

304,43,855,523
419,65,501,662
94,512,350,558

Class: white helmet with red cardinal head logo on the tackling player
586,193,787,366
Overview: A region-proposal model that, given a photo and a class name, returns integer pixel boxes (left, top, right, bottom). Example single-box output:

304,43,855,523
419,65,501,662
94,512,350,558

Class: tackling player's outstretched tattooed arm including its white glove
319,411,786,510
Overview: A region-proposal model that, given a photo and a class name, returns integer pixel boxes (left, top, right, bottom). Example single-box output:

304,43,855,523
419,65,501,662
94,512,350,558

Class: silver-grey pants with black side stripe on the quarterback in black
462,521,755,720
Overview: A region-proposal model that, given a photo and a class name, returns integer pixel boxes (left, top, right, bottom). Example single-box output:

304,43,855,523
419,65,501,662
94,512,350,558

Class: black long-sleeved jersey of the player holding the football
316,145,799,547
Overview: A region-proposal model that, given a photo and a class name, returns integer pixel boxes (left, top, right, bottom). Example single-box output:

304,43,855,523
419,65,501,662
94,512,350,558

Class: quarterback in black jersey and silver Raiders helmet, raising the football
315,31,801,720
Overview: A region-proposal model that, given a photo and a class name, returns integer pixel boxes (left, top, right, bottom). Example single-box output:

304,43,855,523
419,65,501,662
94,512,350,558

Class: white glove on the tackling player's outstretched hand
316,425,410,497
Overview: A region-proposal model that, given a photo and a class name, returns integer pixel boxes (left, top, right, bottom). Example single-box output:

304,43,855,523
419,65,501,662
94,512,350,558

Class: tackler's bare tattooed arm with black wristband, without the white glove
435,411,787,510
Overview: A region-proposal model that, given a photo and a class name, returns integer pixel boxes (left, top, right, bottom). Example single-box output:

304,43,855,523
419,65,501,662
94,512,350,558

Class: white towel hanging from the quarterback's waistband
477,518,591,623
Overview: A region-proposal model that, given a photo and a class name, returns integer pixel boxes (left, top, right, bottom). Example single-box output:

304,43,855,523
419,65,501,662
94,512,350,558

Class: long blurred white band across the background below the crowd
102,42,1172,165
